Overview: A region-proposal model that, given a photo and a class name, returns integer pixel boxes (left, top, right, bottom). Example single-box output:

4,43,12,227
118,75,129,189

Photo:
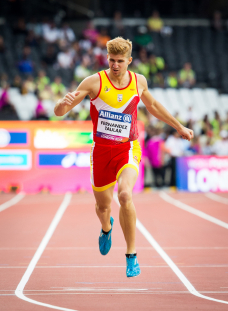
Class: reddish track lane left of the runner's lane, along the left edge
0,195,66,311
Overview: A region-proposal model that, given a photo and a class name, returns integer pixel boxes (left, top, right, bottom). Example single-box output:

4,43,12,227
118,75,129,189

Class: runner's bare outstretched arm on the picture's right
137,74,194,141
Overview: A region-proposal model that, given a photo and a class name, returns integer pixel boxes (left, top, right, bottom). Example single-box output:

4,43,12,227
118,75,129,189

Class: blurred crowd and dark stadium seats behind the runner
0,0,228,187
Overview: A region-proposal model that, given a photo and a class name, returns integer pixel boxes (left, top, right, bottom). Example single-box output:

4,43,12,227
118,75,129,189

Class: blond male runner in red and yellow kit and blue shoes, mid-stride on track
54,37,193,277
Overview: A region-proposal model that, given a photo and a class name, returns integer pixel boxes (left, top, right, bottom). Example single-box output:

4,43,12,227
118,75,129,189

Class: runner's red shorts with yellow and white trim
90,140,142,191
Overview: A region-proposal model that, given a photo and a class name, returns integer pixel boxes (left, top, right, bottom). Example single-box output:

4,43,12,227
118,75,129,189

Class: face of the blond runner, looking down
107,54,132,77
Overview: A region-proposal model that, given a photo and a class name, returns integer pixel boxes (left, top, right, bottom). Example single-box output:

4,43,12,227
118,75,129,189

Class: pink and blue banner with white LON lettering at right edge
176,156,228,192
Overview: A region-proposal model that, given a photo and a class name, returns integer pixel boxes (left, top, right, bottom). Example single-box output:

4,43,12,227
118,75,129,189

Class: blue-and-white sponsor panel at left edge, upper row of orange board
0,129,28,148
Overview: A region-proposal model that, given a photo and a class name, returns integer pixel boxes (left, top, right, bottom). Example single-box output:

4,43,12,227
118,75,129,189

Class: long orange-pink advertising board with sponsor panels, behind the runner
0,121,144,193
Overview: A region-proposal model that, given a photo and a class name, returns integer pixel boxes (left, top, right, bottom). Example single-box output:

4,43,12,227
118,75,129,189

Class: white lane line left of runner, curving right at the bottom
15,192,76,311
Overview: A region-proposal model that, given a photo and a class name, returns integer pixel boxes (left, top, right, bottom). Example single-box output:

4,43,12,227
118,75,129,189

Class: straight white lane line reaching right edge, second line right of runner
159,191,228,229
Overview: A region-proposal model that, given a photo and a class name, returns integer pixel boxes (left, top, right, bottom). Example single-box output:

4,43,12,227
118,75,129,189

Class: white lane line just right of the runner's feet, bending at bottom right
114,192,228,304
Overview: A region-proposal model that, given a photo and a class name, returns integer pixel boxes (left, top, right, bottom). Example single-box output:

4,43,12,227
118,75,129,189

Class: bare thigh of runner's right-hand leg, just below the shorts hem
118,167,138,193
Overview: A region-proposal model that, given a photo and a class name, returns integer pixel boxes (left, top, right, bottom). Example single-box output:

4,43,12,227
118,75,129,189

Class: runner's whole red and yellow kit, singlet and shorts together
90,71,141,191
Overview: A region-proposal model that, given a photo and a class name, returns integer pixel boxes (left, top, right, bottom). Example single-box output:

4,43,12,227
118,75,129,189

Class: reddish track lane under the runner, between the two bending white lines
18,194,227,311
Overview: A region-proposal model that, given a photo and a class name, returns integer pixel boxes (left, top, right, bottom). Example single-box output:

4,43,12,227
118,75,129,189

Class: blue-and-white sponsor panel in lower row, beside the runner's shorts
38,152,90,168
